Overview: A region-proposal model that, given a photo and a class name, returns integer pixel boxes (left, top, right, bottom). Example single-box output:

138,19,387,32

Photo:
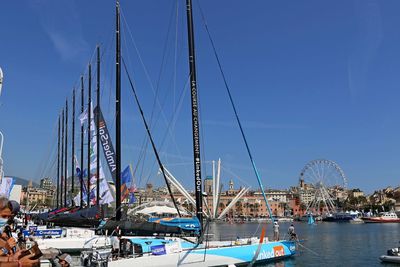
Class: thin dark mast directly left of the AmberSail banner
96,45,100,206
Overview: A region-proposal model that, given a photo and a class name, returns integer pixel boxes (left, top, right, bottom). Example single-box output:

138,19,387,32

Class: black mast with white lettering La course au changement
186,0,203,231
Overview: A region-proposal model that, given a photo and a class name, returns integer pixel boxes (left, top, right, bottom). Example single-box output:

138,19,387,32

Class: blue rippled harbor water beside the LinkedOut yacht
74,222,400,267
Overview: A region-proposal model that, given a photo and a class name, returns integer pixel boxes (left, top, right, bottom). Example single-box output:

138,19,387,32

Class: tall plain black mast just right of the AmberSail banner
115,0,121,221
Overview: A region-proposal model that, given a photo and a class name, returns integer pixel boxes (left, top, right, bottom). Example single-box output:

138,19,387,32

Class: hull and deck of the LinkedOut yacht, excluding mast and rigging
82,237,296,267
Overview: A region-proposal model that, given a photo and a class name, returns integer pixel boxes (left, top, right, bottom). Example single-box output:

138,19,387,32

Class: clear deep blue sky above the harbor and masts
0,0,400,192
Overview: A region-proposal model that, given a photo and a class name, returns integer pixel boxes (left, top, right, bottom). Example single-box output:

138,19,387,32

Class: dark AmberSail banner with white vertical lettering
94,107,117,183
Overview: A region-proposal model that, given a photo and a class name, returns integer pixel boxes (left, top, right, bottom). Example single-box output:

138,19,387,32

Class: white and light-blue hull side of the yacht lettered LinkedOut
108,241,296,267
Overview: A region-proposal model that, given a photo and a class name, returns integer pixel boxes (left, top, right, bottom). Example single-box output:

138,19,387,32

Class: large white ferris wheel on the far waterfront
299,159,347,214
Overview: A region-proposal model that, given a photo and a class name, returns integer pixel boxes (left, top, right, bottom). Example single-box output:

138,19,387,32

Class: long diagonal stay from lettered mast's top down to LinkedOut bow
197,2,274,221
